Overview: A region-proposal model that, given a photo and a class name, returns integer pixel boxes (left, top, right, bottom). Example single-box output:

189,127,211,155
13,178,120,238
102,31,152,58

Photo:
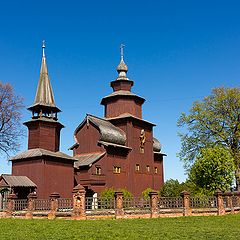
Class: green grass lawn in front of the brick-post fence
0,214,240,240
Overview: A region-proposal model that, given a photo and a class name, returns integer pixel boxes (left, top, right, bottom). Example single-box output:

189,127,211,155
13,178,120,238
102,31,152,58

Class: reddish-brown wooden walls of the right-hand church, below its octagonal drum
75,118,163,196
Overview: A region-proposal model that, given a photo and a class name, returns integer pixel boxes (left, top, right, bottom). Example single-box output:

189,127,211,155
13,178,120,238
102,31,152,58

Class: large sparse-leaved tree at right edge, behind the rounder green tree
178,87,240,190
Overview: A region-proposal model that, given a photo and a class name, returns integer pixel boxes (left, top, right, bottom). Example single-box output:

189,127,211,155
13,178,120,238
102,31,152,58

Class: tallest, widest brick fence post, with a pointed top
72,184,86,220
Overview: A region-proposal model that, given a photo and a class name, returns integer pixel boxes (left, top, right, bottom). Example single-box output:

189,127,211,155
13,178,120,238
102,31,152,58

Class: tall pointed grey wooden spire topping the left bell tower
28,41,60,114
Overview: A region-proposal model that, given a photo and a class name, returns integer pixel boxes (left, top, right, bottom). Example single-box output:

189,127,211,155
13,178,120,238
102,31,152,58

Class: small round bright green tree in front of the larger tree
189,146,234,193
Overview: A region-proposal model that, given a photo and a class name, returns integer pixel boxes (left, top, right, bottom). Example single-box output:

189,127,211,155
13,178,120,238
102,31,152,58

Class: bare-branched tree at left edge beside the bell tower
0,82,23,156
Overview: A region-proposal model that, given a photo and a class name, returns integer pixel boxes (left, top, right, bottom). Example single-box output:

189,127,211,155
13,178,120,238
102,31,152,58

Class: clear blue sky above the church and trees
0,0,240,181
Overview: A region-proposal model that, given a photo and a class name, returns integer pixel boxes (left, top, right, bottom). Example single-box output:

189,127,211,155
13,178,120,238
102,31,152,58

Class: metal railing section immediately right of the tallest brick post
85,197,115,211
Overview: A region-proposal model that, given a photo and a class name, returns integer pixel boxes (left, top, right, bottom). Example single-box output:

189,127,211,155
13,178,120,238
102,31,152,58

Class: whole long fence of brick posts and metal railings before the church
1,188,240,219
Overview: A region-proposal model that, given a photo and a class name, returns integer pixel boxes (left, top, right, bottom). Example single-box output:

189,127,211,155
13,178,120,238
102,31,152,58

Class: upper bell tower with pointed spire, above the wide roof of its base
24,41,64,152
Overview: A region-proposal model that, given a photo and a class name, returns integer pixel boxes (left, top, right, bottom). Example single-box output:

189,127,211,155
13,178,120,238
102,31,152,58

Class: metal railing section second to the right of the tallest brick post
123,197,150,210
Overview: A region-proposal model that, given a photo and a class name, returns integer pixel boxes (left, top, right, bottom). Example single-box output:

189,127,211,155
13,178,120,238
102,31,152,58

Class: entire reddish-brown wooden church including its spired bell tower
0,44,165,198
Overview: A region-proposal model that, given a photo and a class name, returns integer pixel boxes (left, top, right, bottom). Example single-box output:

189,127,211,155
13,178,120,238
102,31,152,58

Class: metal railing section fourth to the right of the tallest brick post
190,196,217,208
